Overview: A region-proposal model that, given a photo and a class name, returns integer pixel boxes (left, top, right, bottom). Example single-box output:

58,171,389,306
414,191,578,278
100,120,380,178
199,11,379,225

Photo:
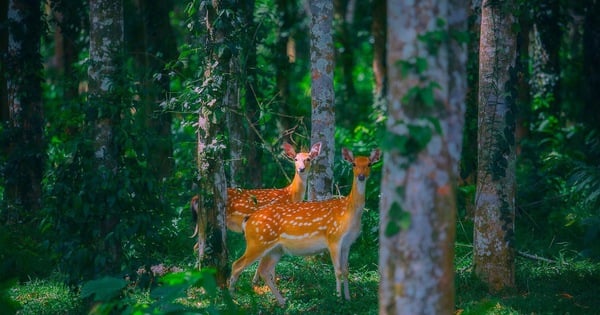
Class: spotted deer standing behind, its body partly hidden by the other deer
190,142,321,257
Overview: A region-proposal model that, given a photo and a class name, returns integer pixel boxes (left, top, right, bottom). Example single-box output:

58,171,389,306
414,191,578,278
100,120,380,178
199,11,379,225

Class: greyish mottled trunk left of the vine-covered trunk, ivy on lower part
88,0,123,273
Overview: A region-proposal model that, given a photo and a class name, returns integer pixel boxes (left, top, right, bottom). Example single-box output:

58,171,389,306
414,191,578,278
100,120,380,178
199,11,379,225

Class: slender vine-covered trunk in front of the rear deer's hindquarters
197,0,239,286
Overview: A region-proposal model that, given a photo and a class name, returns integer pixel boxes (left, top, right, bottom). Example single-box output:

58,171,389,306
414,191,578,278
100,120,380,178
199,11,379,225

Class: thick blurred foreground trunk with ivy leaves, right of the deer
379,1,467,314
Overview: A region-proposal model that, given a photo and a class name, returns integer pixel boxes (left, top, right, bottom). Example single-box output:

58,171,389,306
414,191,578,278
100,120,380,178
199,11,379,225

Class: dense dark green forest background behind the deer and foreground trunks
0,0,600,314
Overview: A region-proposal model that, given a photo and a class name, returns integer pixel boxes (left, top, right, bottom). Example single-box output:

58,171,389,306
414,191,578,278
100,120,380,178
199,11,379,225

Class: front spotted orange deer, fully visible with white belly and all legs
229,148,381,307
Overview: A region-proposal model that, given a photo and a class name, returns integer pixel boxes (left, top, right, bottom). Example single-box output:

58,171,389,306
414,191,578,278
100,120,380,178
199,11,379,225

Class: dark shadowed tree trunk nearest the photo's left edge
1,0,46,223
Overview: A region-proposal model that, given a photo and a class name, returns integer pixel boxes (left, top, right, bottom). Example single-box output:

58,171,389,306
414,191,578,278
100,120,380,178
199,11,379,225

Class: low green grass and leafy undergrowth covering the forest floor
9,217,600,315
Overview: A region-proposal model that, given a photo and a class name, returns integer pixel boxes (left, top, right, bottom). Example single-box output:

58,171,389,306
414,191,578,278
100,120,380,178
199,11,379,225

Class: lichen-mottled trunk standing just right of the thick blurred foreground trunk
473,0,516,291
